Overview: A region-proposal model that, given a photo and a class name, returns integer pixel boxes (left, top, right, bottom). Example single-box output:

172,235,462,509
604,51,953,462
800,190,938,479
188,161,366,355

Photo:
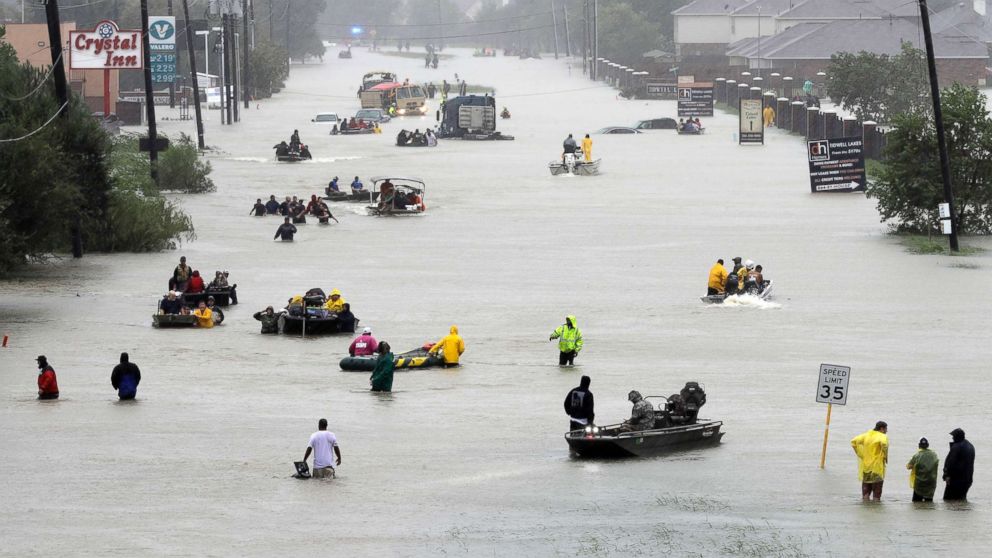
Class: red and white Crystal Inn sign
69,20,144,70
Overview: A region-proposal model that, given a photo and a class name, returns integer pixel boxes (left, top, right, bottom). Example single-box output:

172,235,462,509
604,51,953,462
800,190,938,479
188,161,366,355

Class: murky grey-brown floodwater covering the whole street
0,49,992,557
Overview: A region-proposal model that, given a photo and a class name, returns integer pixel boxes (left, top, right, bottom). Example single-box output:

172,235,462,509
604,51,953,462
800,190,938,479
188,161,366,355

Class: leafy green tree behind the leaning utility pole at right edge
868,84,992,234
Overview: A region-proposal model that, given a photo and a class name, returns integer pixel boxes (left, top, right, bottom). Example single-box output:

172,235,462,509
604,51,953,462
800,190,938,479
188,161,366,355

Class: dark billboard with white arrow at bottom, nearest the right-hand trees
806,136,868,194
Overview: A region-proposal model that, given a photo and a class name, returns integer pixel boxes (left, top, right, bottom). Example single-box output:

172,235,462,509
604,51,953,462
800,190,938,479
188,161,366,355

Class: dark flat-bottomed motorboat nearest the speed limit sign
565,382,723,458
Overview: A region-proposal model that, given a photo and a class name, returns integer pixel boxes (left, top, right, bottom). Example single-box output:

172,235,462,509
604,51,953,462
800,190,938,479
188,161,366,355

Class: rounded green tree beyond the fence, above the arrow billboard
827,42,930,123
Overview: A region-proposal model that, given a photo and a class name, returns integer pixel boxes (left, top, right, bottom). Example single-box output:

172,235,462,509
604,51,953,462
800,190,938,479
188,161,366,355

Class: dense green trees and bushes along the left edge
0,27,192,272
